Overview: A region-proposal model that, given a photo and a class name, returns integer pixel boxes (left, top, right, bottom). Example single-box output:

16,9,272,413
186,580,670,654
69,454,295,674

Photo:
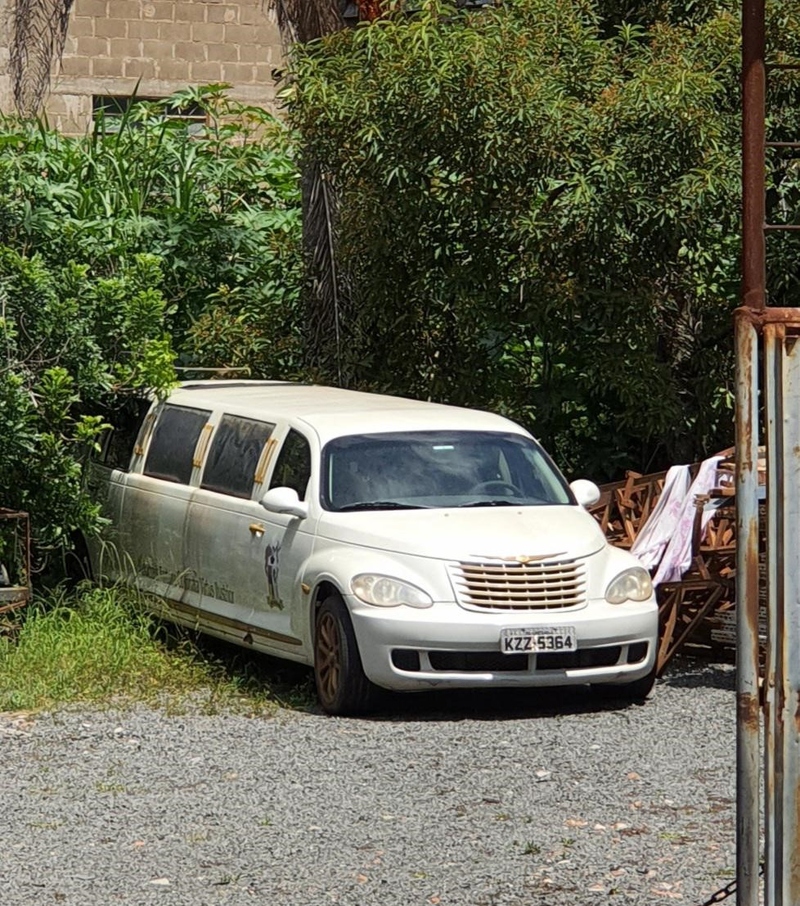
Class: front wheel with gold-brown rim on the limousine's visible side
314,595,377,715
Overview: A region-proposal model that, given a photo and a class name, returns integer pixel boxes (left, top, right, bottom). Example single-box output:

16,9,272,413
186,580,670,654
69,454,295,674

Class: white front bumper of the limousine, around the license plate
347,596,658,691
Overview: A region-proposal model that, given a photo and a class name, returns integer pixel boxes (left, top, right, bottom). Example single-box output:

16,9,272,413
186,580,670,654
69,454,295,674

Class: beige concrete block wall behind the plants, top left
0,0,281,134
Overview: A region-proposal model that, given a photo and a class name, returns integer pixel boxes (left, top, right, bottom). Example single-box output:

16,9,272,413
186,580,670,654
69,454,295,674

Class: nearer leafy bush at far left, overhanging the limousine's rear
0,246,174,561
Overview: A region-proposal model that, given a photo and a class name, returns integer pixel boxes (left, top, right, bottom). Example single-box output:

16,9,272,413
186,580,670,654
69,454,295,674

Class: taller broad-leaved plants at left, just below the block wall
0,85,300,364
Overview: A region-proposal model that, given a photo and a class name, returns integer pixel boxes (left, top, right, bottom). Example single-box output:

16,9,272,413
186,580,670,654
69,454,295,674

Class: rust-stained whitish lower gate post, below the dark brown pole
735,309,760,906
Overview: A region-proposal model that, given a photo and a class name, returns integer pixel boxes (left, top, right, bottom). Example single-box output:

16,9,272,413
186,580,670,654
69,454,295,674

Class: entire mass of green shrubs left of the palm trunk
0,86,300,565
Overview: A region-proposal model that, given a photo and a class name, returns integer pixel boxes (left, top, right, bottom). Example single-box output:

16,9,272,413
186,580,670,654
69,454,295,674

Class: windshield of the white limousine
322,431,575,512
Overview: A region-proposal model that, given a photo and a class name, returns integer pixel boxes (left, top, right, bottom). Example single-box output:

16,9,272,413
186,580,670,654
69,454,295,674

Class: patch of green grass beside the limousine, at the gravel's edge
0,583,284,714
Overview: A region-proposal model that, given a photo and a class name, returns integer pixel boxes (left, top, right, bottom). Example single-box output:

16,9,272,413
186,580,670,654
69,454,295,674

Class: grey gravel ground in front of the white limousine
0,660,735,906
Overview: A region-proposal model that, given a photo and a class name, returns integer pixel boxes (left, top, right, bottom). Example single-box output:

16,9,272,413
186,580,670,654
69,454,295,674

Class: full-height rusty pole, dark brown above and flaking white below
735,0,766,906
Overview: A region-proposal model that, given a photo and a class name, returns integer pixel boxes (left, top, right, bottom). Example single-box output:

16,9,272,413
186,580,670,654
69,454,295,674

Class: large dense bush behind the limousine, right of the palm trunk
288,0,800,478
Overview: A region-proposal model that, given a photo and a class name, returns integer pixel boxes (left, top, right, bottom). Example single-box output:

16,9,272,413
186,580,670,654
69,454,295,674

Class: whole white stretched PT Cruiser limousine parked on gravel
90,380,657,714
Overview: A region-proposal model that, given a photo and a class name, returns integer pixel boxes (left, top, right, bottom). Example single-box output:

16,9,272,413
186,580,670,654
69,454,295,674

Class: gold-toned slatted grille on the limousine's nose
450,560,586,611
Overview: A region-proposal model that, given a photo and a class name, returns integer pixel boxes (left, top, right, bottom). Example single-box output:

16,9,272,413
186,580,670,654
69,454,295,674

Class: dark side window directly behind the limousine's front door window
202,415,275,498
